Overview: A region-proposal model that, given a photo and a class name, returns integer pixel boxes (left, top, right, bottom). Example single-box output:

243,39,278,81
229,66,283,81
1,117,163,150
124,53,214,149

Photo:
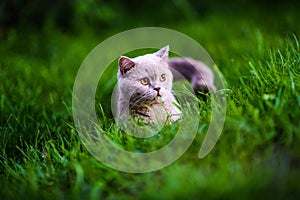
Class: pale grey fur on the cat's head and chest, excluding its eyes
117,46,181,124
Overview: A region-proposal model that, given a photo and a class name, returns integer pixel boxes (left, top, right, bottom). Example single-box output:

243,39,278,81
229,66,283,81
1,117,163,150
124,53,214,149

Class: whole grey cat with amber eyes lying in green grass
117,46,215,124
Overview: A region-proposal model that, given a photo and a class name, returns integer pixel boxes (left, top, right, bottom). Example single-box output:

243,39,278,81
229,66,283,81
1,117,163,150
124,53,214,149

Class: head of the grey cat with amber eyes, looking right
118,46,173,103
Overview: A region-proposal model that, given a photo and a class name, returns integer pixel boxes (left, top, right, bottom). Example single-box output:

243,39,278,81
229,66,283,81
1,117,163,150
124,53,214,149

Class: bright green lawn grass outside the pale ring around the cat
0,5,300,199
